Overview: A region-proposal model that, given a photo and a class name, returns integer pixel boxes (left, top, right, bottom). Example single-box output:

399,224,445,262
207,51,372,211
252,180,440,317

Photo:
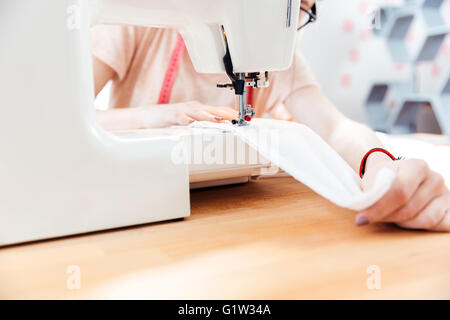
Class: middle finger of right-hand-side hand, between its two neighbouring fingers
382,171,446,222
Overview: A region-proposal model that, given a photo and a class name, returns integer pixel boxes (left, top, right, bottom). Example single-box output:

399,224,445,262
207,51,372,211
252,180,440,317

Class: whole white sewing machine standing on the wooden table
0,0,300,245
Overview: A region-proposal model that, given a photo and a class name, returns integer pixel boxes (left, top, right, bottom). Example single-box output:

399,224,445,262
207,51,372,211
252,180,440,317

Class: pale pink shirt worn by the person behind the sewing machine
91,25,316,120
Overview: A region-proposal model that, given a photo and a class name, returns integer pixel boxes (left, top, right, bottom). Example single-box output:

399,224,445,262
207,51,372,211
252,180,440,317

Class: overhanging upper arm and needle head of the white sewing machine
92,0,300,73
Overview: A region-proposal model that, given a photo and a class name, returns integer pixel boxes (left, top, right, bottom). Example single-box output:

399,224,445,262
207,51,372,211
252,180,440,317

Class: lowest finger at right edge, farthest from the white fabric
398,191,450,231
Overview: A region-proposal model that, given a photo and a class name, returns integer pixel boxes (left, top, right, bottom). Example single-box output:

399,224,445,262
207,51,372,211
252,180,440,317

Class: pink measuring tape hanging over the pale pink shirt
158,34,253,105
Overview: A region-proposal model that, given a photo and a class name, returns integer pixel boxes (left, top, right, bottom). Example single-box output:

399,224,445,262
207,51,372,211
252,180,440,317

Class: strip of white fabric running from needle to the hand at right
191,119,395,211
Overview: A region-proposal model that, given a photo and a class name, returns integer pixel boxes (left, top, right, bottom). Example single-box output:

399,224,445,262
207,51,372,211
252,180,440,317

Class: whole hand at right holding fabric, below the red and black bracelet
356,154,450,231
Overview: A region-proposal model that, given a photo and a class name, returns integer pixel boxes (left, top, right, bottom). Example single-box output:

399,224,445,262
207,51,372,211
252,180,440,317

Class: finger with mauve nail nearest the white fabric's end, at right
356,160,430,225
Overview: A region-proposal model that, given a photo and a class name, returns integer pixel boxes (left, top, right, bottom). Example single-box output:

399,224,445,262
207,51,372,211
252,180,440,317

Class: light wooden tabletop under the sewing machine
0,178,450,299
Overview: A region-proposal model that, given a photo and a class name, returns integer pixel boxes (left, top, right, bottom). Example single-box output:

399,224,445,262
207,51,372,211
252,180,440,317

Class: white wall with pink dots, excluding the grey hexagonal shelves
299,0,450,121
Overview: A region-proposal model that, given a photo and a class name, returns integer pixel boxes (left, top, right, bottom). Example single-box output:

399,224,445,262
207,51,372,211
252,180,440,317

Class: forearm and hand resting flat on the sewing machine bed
97,101,238,130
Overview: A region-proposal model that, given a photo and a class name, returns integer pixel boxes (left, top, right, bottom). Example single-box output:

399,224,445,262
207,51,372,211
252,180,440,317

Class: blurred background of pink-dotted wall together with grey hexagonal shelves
96,0,450,135
